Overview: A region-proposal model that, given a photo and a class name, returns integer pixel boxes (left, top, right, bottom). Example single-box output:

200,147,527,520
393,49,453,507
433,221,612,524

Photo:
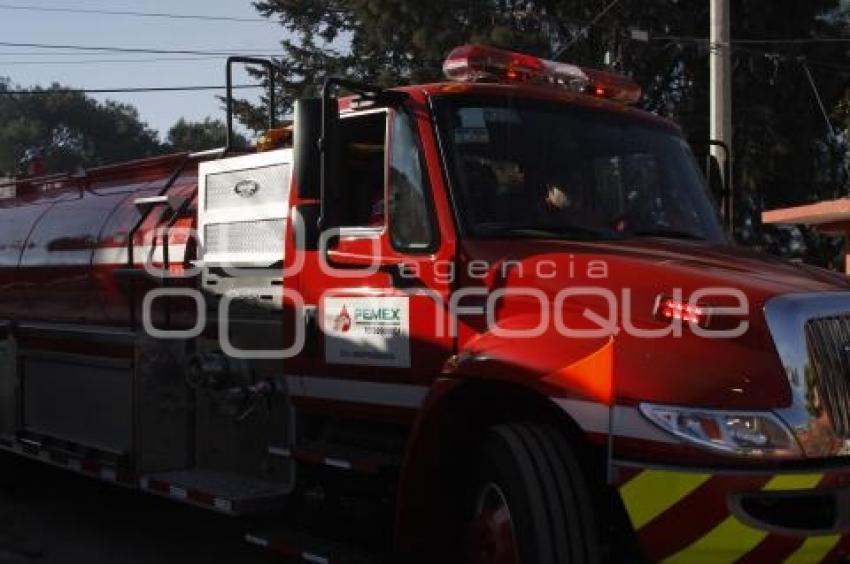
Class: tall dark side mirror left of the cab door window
293,98,322,200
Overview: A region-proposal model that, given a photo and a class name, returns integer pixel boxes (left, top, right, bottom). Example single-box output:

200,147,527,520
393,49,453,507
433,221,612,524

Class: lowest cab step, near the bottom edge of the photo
245,531,380,564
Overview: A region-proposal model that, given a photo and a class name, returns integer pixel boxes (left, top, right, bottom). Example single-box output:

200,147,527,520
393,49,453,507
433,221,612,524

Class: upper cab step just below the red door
268,442,401,474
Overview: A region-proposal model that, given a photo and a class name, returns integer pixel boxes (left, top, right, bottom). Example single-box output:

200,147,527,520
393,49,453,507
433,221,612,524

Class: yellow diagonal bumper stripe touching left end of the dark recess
664,516,767,564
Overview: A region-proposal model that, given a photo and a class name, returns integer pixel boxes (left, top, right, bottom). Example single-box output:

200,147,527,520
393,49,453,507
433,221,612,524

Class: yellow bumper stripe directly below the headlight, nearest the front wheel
620,470,711,530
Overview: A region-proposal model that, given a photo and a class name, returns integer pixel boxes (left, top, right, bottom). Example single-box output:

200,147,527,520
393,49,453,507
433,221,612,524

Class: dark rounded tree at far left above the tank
0,79,164,175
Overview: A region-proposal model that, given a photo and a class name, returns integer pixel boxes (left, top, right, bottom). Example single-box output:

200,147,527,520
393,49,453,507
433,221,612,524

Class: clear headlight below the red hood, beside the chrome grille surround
640,403,802,458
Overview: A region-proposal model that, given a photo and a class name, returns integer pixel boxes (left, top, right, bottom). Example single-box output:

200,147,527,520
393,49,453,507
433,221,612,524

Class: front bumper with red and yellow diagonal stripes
617,463,850,564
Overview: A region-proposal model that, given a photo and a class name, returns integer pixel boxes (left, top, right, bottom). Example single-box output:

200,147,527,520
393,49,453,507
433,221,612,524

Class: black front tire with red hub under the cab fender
462,423,599,564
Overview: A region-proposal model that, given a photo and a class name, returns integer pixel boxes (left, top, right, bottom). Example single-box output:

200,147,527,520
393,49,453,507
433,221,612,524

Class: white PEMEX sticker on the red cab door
322,296,410,368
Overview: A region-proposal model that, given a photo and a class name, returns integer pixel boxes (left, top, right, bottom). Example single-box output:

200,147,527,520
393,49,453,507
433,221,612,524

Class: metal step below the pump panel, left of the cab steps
139,469,289,515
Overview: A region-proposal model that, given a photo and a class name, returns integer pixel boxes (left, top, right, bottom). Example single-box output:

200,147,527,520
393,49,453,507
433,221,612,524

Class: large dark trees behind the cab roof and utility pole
239,0,850,239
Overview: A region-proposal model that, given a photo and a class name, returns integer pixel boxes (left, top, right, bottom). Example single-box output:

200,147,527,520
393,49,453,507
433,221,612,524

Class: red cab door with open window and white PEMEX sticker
301,103,454,383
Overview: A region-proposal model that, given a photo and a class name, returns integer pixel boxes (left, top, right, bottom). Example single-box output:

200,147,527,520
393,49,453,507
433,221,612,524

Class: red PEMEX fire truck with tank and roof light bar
0,46,850,564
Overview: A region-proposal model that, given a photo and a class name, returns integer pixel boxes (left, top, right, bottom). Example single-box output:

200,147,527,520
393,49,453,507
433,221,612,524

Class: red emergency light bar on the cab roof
443,45,641,104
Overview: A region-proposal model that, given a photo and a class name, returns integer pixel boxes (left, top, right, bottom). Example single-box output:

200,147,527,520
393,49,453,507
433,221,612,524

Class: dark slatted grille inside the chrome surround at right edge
805,316,850,438
